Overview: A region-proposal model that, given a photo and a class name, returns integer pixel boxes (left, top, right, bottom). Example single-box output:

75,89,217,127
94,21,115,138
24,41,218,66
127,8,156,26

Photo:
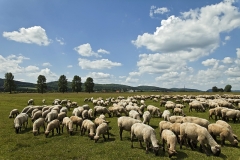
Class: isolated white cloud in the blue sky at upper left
3,26,50,46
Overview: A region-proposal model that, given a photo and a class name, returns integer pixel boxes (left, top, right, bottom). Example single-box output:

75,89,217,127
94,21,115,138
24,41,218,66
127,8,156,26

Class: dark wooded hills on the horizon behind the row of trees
0,78,202,92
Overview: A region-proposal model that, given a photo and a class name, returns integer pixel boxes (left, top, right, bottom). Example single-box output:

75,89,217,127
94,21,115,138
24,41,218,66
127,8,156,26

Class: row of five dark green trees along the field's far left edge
3,72,94,94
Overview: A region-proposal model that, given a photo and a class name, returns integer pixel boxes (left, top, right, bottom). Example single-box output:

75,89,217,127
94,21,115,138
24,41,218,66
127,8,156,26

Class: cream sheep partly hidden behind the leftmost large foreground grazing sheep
118,116,142,140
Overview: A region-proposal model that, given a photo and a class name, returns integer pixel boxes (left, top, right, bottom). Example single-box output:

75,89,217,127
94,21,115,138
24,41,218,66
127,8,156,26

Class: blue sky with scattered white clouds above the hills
0,0,240,91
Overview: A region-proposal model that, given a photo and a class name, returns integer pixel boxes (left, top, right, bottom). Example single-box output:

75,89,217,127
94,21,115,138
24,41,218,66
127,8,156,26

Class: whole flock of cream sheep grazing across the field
9,95,240,157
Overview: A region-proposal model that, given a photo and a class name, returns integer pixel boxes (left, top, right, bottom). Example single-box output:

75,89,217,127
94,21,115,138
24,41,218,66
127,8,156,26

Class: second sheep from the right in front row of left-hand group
81,119,96,139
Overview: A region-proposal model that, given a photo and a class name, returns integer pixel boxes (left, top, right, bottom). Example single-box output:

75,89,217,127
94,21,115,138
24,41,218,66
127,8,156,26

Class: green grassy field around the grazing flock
0,92,240,160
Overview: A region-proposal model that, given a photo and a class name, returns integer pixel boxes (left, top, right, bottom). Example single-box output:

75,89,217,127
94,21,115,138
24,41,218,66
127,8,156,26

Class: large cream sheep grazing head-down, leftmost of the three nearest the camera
131,123,159,156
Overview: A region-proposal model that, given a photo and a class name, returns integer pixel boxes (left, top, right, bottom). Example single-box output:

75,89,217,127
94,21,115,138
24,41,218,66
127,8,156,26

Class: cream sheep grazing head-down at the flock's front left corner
14,113,28,133
